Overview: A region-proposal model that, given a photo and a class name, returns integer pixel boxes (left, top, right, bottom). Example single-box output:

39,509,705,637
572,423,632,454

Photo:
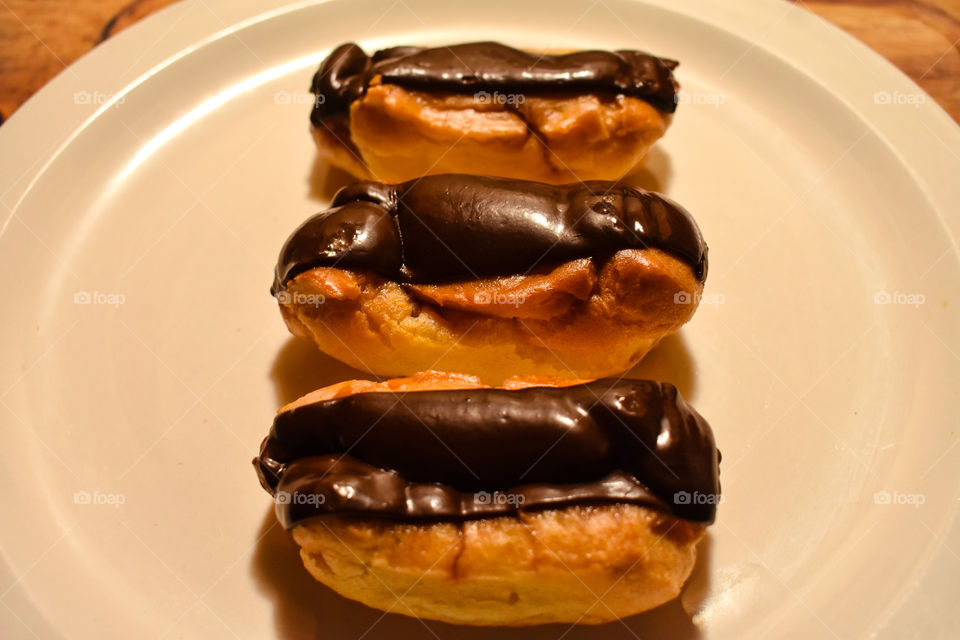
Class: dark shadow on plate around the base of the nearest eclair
252,509,710,640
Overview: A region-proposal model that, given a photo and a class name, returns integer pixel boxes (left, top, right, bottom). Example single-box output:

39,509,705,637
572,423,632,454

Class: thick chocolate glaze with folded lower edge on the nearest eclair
253,379,720,528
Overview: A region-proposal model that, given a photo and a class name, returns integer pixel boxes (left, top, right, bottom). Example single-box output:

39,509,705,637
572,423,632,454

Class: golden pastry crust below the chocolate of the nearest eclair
293,504,704,626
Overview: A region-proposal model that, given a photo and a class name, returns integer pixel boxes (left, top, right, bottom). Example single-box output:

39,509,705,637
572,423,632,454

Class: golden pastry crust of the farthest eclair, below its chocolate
313,78,672,184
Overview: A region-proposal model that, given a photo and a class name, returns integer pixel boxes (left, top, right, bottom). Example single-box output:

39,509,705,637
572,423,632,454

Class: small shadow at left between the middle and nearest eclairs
270,337,376,406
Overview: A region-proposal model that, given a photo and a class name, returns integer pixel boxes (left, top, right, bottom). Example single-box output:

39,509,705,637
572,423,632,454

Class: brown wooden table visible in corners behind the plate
0,0,960,122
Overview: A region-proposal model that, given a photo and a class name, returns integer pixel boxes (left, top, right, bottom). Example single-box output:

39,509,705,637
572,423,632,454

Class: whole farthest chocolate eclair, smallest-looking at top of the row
310,42,677,184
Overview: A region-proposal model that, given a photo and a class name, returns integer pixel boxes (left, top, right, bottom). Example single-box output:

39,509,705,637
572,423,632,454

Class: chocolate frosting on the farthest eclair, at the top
310,42,678,126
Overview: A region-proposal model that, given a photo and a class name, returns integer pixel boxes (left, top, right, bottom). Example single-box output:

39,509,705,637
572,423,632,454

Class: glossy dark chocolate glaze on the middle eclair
271,174,707,295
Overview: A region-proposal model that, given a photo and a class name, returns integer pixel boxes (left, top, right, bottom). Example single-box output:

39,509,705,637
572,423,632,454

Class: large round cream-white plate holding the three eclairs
0,0,960,639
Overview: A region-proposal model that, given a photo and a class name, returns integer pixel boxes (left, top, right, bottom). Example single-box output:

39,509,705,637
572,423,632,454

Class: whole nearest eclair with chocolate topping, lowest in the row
253,372,720,626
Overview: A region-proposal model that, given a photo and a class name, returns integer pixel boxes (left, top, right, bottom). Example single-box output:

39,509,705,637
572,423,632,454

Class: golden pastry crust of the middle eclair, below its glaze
278,249,703,384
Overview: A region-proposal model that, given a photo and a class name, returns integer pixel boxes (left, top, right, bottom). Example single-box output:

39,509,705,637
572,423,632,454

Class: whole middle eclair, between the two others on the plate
271,175,707,383
